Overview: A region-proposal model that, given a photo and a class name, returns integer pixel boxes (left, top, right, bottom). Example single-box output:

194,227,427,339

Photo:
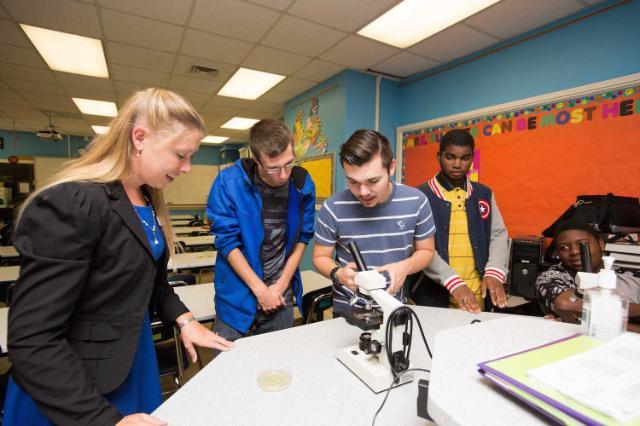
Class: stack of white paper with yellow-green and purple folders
479,333,640,425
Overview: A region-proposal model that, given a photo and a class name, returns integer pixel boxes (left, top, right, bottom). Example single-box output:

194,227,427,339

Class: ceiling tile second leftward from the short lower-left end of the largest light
260,15,347,56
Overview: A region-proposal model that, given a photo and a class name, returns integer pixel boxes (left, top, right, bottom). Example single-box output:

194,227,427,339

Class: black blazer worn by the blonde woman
8,182,187,425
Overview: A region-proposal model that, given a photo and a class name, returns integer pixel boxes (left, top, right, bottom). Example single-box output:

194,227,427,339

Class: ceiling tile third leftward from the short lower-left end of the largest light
189,0,280,42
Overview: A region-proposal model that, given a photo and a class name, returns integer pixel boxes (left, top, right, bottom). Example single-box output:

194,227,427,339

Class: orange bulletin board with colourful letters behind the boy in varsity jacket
398,74,640,237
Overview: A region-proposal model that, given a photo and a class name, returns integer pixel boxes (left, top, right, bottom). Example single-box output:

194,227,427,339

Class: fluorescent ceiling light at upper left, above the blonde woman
20,24,109,78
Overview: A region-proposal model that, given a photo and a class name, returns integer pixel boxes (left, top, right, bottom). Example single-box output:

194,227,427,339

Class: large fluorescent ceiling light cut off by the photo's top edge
358,0,499,49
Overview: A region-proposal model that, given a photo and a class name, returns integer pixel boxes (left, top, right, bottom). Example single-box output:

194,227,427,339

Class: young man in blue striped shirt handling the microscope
313,130,435,316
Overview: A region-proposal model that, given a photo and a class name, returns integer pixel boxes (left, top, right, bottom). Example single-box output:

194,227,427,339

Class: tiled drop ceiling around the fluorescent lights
0,0,599,142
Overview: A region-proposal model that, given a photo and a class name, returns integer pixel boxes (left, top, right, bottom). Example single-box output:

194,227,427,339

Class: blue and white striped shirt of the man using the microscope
315,182,436,313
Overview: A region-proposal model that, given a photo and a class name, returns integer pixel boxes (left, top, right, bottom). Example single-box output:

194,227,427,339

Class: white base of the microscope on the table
336,345,413,393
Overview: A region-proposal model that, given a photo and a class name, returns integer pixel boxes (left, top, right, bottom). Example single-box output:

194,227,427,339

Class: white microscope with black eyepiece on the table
336,242,413,393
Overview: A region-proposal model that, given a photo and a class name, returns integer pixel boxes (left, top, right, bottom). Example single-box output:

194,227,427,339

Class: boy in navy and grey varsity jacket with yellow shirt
412,129,509,313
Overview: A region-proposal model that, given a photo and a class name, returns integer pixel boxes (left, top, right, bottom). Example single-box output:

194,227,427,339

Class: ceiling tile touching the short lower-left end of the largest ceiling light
320,35,400,69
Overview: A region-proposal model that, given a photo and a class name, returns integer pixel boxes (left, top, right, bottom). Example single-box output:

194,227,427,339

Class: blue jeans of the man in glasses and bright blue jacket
213,288,293,357
